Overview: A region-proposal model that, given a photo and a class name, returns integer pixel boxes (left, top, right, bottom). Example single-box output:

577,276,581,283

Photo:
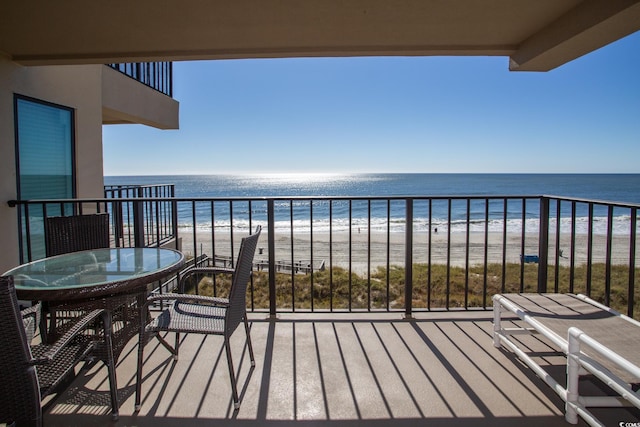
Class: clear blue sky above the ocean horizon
103,32,640,175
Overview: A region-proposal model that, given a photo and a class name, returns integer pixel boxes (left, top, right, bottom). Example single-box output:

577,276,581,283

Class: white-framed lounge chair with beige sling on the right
493,294,640,426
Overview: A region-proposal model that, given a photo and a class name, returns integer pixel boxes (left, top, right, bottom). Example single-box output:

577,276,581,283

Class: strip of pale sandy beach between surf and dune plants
180,230,637,274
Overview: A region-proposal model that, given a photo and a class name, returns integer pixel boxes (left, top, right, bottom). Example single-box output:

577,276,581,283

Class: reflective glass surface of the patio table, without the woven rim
4,248,184,291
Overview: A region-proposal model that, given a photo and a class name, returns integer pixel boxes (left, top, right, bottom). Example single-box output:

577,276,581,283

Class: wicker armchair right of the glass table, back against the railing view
135,227,261,411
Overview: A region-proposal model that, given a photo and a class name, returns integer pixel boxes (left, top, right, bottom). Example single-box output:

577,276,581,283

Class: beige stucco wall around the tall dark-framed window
0,57,104,273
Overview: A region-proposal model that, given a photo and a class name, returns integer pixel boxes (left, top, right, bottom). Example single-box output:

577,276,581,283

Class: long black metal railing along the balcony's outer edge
10,185,640,318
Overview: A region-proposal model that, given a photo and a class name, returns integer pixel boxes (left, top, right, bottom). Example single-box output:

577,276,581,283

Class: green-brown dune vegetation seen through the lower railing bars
185,264,640,318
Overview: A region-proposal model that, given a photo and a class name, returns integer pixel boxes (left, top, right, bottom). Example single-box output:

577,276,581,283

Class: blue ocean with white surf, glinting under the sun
105,174,640,234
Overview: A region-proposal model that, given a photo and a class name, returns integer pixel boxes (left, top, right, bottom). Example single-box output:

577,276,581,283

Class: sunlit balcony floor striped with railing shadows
44,310,640,427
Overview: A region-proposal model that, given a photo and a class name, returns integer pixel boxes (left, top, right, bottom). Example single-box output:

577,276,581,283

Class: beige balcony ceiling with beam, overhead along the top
0,0,640,71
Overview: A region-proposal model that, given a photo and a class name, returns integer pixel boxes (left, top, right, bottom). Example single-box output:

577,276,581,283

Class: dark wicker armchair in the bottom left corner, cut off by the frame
0,276,118,427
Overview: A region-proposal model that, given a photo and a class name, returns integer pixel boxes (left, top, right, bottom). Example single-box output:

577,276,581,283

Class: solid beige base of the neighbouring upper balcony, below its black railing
102,65,179,129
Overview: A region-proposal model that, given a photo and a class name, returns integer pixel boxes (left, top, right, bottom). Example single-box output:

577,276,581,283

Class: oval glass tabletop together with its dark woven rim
4,248,184,303
